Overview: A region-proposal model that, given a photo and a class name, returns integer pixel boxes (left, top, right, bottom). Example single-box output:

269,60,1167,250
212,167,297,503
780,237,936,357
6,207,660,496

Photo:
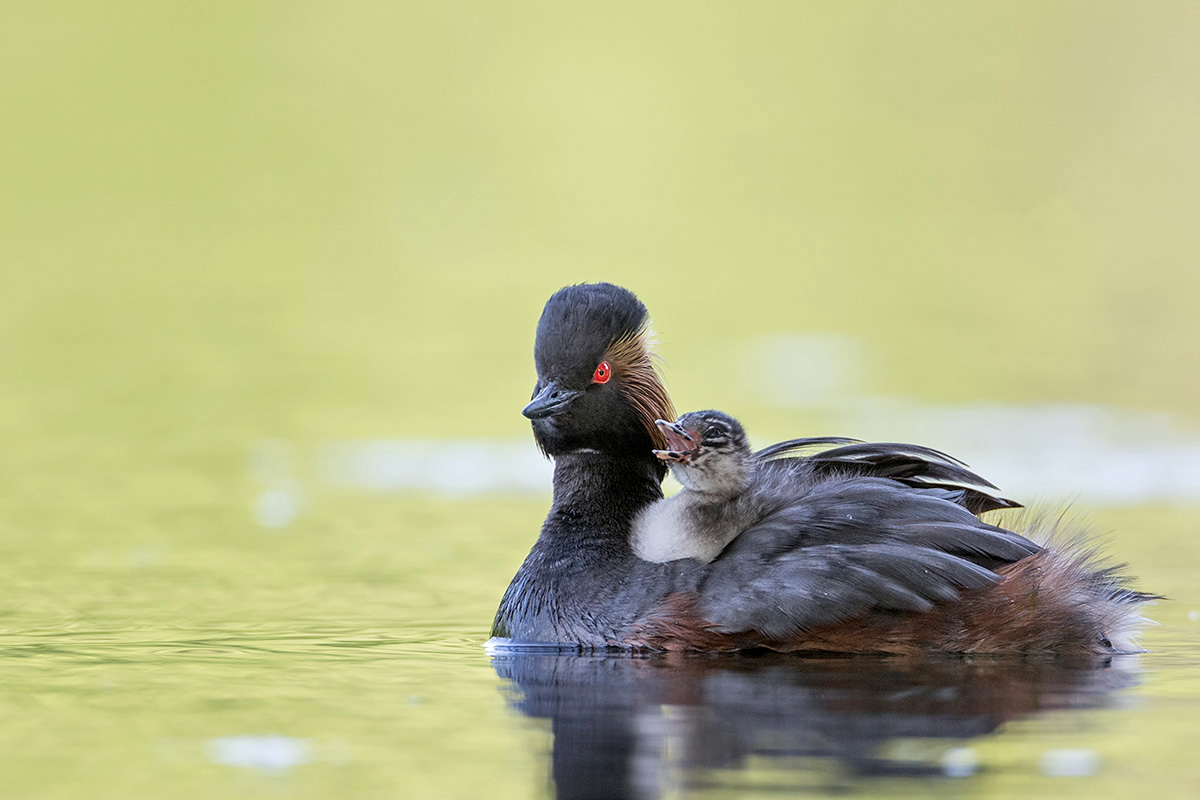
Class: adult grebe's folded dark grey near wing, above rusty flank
696,477,1040,639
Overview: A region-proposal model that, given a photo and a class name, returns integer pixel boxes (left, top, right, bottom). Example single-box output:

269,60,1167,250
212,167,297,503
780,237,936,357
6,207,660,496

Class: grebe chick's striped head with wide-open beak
654,411,752,497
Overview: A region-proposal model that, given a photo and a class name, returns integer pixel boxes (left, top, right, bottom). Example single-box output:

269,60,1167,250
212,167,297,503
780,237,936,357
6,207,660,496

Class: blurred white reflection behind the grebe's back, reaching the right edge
743,333,1200,506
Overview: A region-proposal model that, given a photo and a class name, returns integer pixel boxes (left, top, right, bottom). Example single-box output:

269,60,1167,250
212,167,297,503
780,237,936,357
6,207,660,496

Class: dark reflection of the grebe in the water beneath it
492,651,1138,800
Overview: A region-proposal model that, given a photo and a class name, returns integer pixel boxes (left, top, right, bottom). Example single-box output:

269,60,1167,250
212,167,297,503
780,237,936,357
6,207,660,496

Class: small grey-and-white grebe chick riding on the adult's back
631,411,762,564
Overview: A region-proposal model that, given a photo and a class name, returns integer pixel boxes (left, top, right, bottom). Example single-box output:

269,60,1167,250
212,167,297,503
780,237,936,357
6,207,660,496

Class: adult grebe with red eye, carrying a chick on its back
493,283,1153,656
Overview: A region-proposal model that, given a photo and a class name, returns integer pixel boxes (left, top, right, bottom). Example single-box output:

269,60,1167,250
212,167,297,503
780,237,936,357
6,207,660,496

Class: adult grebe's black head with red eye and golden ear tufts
522,283,674,456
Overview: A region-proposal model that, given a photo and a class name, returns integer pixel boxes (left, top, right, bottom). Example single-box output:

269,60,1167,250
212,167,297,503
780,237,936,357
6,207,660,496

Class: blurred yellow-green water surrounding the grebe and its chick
0,2,1200,798
